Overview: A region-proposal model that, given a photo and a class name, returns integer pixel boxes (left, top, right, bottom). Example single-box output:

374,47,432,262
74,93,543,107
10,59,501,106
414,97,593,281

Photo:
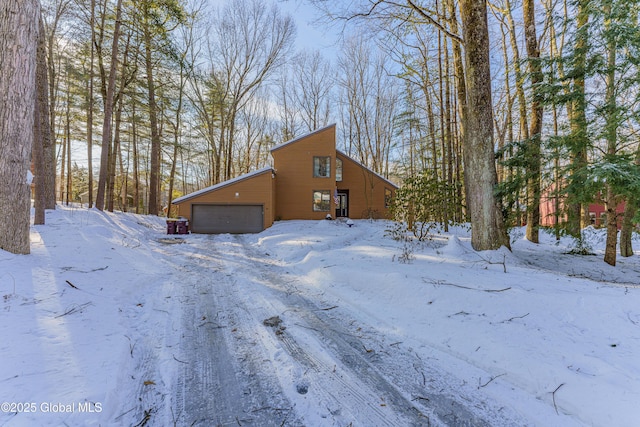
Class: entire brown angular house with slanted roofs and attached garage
173,125,397,233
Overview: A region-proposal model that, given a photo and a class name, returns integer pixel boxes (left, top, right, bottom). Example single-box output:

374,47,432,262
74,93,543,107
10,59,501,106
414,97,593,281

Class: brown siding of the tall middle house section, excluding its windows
271,125,336,219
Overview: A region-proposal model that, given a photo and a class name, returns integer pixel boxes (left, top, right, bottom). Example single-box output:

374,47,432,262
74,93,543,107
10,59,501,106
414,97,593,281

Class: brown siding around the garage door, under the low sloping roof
176,170,275,228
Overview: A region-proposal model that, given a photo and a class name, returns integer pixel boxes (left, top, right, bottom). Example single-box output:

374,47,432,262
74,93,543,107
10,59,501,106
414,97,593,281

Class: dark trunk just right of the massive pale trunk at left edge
32,17,50,224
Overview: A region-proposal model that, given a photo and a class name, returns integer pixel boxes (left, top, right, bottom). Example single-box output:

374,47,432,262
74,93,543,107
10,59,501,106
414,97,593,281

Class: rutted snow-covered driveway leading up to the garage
154,235,520,426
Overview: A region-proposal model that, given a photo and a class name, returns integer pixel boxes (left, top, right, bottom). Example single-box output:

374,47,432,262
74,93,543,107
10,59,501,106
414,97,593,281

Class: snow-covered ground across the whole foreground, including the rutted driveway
0,206,640,427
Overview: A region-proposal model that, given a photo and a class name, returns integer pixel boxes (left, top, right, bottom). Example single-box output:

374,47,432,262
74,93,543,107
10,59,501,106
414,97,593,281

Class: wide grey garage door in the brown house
191,205,264,234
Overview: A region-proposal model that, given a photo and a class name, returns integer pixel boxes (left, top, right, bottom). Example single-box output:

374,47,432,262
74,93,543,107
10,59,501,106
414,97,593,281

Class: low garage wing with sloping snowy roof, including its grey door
173,167,275,234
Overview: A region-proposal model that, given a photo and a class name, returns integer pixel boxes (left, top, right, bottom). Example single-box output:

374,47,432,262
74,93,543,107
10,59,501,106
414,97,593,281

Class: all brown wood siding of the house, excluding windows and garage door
176,125,397,228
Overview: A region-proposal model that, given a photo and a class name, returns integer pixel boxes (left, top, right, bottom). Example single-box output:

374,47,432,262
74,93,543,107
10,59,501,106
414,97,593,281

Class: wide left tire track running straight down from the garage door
173,236,299,426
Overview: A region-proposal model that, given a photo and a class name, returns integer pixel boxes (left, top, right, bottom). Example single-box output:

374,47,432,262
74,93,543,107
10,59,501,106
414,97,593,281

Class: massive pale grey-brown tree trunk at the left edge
0,0,40,254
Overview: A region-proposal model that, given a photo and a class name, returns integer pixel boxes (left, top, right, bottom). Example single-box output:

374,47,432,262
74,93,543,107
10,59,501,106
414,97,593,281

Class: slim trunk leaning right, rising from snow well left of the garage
96,0,122,210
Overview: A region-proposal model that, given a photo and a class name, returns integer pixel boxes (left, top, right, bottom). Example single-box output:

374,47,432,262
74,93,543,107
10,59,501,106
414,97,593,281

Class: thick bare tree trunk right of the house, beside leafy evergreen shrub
460,0,510,250
